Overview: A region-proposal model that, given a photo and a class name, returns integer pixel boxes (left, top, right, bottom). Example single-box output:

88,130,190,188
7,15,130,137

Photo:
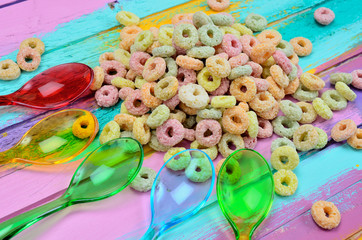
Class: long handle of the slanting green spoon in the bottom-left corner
0,197,69,239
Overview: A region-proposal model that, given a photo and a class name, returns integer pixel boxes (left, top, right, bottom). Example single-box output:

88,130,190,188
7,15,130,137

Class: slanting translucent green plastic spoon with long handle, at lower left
0,138,143,239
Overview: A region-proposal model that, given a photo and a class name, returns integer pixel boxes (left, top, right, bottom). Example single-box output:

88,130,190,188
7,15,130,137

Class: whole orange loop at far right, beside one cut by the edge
331,119,357,142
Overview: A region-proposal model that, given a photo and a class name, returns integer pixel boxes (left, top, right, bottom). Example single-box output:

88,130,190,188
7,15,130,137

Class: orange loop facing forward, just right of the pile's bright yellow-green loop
230,77,256,102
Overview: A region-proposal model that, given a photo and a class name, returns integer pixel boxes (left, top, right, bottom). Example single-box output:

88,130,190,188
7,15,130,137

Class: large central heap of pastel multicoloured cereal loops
91,8,362,193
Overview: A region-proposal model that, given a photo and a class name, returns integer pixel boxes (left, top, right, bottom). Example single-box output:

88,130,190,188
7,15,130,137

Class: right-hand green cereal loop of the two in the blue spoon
185,156,212,182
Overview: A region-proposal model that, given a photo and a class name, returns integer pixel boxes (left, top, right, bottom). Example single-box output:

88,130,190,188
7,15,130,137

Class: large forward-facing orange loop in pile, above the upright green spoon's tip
221,106,249,134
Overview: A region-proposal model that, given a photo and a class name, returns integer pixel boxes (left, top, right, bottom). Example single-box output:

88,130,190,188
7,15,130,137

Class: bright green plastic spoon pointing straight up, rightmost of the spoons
216,149,274,240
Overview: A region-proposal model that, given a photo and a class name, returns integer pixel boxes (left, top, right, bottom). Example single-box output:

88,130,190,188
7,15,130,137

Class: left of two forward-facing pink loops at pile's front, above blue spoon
156,119,185,147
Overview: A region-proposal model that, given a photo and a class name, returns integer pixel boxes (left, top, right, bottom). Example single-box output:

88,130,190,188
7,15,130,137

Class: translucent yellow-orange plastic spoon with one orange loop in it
0,109,99,165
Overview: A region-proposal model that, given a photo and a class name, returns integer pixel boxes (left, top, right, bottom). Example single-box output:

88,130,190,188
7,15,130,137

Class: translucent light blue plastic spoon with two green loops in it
142,149,215,239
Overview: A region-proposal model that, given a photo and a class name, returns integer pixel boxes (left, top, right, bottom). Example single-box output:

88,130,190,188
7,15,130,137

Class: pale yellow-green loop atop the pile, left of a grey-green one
172,23,199,49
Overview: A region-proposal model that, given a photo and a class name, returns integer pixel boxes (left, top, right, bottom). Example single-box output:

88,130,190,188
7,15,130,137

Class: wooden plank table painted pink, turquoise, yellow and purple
0,0,362,240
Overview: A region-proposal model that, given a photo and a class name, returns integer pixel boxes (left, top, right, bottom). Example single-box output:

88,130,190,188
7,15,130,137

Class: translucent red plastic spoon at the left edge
0,63,93,109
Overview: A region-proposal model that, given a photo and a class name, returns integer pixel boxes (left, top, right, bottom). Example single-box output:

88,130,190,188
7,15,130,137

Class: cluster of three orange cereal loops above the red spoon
0,38,45,80
